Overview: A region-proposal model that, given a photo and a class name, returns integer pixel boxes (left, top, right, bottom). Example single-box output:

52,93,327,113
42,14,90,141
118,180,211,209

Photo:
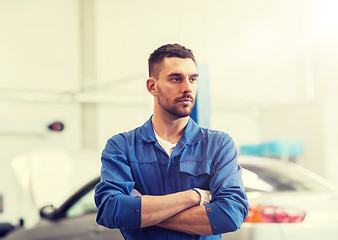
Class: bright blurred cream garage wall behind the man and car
0,0,338,234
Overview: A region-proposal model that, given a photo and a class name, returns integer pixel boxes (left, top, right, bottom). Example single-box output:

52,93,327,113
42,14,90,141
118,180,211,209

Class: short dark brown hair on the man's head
148,43,196,78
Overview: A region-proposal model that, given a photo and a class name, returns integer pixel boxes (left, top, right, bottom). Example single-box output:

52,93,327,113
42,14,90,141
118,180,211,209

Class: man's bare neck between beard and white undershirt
152,112,189,143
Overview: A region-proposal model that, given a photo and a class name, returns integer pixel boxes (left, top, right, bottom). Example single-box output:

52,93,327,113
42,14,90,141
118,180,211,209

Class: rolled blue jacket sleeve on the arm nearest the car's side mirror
94,135,141,228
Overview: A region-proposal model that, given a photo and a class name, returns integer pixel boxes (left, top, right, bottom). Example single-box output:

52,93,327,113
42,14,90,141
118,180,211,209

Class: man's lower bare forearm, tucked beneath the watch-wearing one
157,206,212,236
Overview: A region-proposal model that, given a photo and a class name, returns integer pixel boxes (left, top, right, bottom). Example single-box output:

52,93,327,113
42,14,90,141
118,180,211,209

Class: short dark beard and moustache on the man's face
157,86,195,118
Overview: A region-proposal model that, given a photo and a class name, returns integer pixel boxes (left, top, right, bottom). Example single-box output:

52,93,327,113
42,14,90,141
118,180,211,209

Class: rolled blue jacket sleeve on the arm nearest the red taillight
205,135,249,235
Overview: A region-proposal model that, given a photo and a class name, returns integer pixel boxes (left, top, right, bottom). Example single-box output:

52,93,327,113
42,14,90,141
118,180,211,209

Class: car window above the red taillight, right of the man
241,164,332,192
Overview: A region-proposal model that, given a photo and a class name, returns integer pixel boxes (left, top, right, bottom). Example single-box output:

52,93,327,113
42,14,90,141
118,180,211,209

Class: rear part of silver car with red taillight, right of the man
227,156,338,240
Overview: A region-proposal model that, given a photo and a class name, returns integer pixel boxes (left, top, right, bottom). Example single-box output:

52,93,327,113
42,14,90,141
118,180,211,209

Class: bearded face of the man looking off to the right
156,57,198,118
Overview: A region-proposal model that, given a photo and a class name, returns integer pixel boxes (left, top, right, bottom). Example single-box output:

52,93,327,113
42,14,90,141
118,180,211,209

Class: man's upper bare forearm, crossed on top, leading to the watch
141,190,200,227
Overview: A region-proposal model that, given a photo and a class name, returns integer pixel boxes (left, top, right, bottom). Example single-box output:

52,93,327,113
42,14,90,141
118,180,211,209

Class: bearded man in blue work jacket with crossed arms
95,44,248,240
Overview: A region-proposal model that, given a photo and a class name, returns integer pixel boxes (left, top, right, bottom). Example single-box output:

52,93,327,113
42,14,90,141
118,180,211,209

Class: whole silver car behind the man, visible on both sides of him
5,156,338,240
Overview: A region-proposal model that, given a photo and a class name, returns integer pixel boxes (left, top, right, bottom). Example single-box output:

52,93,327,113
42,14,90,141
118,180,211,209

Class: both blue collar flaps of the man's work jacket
139,116,204,145
